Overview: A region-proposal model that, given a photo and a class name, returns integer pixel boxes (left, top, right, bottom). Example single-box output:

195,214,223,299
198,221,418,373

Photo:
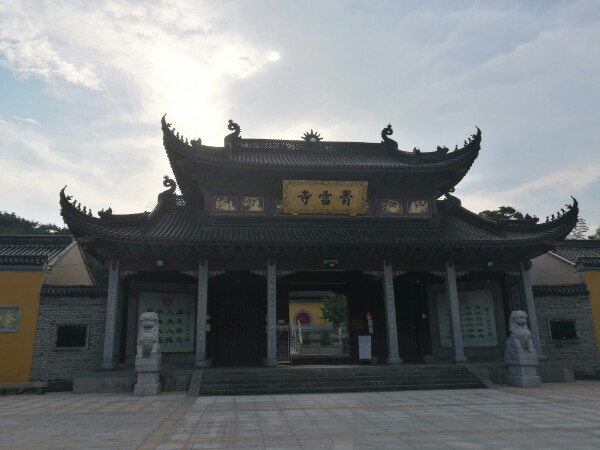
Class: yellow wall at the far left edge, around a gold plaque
0,266,44,383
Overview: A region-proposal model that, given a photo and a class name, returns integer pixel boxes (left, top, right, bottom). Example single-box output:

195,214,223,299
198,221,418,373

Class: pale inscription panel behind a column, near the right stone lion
436,290,498,348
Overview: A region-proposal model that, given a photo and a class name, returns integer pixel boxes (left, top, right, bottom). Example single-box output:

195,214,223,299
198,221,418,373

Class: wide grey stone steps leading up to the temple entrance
195,364,486,395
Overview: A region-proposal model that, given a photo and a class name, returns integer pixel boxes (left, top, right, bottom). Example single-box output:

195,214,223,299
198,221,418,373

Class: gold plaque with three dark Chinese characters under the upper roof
283,180,368,216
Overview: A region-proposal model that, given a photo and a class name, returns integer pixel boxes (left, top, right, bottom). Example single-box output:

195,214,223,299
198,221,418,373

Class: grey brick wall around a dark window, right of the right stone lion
534,286,600,374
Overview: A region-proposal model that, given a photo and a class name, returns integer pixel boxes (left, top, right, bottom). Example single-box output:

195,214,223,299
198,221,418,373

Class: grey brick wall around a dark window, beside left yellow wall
30,286,106,390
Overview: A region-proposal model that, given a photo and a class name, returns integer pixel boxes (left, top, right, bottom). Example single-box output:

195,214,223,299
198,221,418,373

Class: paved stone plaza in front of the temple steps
0,381,600,450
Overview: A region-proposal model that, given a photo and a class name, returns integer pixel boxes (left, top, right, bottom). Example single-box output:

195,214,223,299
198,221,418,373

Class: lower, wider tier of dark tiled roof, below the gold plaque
61,185,578,253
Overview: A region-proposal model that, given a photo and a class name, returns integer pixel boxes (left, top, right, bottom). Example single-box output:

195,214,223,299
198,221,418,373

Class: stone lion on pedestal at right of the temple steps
504,311,541,387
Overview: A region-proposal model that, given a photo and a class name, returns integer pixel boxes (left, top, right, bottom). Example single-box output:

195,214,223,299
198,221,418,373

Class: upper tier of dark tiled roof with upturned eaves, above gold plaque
161,117,481,206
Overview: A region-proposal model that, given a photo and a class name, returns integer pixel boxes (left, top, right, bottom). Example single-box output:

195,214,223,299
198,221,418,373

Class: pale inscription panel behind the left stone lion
139,291,196,353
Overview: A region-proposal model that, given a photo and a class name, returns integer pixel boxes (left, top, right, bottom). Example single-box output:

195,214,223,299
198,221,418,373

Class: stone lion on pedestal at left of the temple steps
133,312,161,396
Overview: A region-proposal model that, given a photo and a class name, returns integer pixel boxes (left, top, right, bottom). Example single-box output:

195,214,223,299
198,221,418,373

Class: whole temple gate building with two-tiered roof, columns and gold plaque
60,117,578,376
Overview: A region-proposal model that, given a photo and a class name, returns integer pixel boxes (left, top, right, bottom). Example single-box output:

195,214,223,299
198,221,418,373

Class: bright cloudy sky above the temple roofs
0,0,600,234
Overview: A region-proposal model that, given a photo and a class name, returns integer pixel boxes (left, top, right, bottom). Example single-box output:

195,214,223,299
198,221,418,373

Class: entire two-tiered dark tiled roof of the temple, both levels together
60,117,578,257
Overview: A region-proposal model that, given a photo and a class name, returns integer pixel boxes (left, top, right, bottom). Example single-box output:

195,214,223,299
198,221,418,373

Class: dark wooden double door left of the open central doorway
209,272,267,367
